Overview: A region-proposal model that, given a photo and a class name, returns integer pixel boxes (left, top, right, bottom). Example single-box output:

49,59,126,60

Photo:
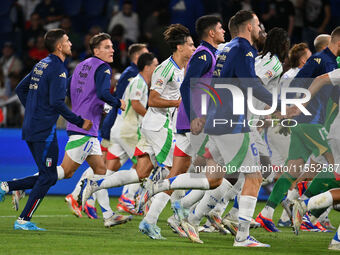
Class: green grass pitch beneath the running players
0,196,340,255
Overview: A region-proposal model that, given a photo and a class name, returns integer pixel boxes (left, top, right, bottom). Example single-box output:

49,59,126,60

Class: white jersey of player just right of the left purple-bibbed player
111,74,148,139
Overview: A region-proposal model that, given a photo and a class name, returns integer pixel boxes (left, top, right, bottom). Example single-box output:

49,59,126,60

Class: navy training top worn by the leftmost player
15,54,84,142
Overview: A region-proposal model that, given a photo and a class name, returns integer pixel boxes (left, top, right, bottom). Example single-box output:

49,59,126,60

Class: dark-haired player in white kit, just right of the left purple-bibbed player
106,53,158,214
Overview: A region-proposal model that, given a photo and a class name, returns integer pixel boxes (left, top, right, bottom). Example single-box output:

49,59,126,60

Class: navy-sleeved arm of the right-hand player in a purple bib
180,51,212,119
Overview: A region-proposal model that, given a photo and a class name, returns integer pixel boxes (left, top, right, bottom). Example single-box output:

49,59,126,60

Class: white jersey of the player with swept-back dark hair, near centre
142,57,184,131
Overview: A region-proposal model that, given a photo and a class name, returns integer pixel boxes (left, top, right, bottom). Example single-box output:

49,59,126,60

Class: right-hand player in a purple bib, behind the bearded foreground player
141,15,226,241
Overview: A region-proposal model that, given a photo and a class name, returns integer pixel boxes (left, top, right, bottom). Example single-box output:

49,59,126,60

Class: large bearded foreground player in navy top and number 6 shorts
142,11,280,247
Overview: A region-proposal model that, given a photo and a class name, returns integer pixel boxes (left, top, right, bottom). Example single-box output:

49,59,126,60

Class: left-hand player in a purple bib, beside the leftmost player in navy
58,33,131,227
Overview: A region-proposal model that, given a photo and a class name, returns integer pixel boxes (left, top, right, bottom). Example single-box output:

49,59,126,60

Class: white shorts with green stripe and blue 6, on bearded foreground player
207,132,261,173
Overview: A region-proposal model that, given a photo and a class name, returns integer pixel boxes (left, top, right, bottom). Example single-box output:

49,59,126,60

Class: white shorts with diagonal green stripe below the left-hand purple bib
65,135,102,165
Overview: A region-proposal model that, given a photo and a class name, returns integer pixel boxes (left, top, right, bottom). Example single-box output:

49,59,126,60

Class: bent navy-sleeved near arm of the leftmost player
48,67,84,127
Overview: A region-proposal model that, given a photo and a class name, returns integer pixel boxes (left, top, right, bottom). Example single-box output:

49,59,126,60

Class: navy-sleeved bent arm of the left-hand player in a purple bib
94,65,125,109
